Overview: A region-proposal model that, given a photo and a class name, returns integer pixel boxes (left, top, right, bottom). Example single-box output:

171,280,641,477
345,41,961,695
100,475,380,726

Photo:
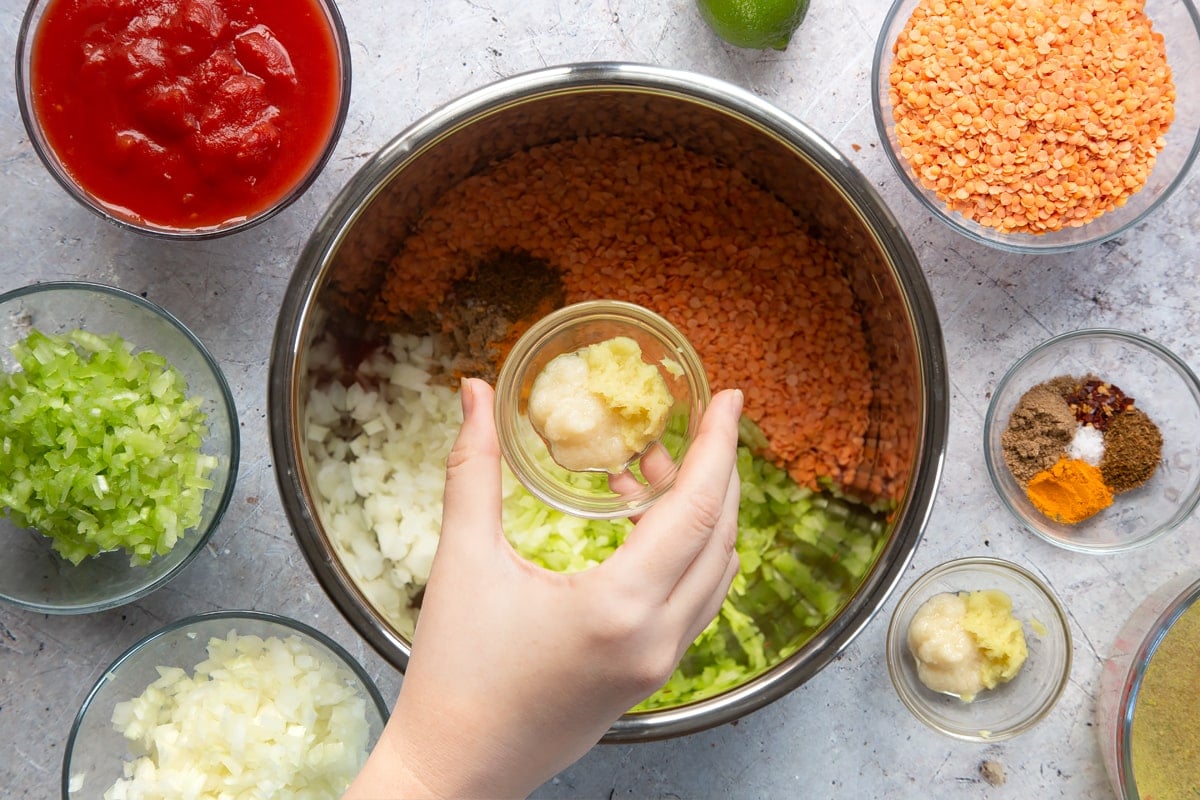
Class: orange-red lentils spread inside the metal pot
372,137,883,500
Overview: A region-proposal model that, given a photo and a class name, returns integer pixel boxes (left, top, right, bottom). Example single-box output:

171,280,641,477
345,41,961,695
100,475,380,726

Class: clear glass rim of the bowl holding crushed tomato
13,0,353,241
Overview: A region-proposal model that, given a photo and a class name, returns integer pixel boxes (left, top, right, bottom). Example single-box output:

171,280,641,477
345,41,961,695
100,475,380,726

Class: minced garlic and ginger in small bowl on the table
907,589,1028,703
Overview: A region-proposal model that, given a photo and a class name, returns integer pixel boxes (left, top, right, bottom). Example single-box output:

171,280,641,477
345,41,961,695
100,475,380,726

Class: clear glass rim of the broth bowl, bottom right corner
1096,571,1200,800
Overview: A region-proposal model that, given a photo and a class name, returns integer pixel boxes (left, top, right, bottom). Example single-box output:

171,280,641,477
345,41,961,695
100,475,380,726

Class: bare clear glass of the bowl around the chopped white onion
62,610,388,800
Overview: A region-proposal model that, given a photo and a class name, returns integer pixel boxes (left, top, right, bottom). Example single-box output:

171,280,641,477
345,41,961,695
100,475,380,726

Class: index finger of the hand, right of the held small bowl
605,390,742,601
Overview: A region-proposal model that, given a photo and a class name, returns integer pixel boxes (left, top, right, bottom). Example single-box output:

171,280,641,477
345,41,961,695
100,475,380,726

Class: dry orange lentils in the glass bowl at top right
888,0,1175,234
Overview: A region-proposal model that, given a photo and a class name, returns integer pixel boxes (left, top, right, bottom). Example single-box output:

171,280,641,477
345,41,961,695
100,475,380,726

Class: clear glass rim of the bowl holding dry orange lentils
871,0,1200,254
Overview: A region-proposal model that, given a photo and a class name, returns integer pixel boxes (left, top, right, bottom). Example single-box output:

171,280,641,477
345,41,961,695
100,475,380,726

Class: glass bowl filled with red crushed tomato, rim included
17,0,350,239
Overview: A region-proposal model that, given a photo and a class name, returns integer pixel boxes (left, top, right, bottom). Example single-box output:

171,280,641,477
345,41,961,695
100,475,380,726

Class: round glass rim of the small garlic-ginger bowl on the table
884,555,1074,744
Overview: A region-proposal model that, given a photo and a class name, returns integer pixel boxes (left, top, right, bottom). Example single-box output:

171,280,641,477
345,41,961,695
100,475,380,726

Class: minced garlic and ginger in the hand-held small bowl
528,336,674,473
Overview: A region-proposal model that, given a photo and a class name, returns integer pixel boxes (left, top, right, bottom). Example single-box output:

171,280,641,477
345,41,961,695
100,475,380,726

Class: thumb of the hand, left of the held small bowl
439,378,503,554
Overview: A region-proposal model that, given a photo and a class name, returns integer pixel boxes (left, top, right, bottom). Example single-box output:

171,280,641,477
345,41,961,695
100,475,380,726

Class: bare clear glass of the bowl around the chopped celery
0,282,240,614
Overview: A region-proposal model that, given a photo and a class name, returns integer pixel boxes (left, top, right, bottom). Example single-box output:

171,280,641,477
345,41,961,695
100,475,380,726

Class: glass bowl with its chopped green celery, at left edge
0,282,239,614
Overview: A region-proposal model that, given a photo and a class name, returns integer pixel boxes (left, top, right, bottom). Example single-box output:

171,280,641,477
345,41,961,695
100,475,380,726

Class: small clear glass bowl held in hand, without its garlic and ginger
496,300,712,519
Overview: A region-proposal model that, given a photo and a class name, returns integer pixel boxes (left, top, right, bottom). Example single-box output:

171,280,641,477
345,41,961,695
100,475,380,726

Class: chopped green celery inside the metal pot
504,417,886,710
